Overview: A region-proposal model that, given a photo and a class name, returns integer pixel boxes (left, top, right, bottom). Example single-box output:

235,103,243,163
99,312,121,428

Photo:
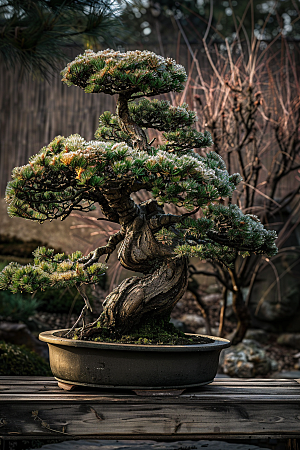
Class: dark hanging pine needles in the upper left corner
0,0,124,79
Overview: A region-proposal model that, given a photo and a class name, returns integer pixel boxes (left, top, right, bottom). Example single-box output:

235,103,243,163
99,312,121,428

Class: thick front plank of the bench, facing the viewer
1,401,300,437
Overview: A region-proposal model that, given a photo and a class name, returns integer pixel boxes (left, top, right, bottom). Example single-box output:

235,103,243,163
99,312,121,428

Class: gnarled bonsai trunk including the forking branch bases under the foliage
83,189,188,336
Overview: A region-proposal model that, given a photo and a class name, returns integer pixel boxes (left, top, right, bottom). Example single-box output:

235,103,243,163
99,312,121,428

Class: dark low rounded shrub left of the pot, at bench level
0,341,52,377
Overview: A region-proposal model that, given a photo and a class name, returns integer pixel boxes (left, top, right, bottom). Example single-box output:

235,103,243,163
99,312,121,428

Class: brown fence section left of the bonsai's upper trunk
0,57,115,196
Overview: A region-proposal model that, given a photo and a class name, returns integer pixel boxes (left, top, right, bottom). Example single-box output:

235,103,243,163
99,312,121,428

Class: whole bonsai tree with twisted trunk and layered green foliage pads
0,50,277,339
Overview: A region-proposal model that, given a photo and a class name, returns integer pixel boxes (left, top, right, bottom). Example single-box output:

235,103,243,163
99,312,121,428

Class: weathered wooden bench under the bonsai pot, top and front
0,377,300,448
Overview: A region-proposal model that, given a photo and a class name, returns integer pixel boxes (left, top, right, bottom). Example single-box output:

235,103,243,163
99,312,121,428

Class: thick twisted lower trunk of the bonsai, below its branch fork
100,215,188,334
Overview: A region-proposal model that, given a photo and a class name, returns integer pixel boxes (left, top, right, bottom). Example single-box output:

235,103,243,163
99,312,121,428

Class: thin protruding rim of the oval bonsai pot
39,329,231,352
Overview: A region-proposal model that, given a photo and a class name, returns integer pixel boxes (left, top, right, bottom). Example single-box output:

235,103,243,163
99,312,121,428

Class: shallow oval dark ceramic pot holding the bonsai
39,330,230,390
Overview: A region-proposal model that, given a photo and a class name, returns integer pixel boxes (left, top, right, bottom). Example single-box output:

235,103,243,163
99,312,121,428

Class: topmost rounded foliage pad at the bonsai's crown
61,49,187,98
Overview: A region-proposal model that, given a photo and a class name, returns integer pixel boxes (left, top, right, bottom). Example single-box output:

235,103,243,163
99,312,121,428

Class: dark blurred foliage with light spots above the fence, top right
117,0,300,47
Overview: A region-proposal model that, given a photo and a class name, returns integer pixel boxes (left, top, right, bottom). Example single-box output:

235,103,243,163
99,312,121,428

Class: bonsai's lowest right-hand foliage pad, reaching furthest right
156,204,277,267
